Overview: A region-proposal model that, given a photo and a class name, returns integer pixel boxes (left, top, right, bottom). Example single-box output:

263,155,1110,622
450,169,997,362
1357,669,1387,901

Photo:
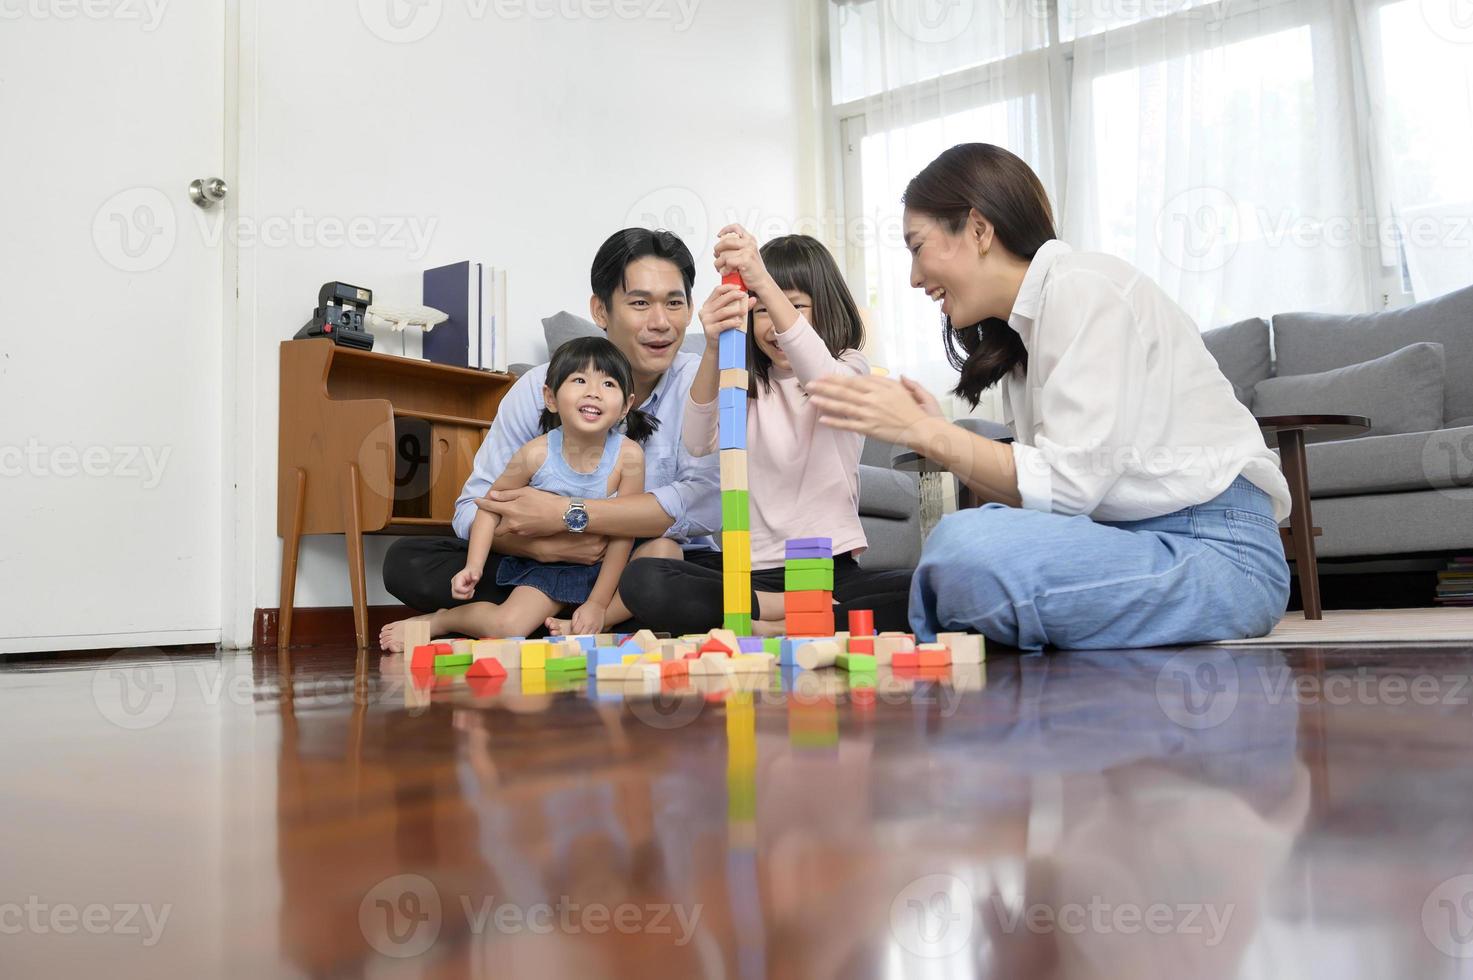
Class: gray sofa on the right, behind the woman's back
1202,287,1473,559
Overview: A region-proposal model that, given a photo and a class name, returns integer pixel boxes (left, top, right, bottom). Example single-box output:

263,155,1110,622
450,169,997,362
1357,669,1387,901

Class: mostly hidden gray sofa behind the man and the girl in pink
510,312,921,570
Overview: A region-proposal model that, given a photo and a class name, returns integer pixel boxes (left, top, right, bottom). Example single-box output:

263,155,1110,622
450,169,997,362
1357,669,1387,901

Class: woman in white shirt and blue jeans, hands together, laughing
809,143,1289,648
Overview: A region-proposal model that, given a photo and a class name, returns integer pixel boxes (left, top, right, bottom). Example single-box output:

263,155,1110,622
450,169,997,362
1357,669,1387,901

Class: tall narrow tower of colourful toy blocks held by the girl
717,273,751,637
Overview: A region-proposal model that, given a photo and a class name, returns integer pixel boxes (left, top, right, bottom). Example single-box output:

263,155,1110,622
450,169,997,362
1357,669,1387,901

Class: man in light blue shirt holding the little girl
383,228,720,610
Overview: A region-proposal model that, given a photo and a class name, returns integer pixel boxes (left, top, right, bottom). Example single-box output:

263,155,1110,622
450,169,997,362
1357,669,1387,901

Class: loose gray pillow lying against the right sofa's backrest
1254,343,1444,436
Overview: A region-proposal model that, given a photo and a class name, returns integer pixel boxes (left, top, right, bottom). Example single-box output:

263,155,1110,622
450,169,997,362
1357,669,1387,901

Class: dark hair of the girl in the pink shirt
747,234,865,396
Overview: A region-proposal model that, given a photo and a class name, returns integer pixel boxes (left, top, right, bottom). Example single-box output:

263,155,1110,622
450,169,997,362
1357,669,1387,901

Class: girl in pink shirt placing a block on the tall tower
682,225,903,634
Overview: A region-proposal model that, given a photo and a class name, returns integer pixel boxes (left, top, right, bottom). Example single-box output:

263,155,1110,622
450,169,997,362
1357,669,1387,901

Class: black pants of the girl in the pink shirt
619,551,912,637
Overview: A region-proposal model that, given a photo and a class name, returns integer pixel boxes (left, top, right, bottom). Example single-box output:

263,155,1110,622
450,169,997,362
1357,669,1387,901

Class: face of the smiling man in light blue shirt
592,255,691,379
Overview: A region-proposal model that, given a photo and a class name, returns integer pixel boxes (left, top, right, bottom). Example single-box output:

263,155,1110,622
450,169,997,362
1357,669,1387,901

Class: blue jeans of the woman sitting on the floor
910,477,1289,650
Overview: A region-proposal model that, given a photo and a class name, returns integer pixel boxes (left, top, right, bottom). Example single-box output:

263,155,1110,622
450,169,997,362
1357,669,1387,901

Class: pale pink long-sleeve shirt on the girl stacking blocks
681,317,869,569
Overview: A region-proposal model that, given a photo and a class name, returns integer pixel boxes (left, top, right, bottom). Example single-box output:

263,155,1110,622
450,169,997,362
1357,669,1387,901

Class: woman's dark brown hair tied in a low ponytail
900,143,1058,408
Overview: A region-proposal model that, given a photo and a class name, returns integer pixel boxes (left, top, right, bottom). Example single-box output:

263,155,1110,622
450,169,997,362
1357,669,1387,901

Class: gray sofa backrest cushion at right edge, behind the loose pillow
1274,286,1473,421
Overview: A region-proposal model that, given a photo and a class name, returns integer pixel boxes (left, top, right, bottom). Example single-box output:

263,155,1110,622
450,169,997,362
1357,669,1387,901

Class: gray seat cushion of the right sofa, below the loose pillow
1305,426,1473,498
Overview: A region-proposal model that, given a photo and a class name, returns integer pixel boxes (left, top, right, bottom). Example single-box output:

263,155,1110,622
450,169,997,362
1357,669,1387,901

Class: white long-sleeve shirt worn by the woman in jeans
1002,240,1289,520
